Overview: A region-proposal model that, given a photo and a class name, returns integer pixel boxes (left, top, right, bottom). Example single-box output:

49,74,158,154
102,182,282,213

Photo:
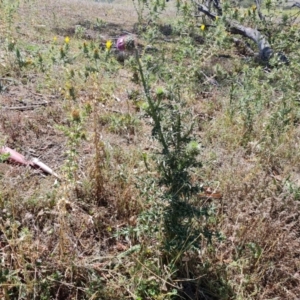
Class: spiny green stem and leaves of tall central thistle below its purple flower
136,47,213,262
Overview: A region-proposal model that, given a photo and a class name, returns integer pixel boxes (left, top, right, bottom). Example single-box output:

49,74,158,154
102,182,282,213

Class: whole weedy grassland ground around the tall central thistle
0,0,300,300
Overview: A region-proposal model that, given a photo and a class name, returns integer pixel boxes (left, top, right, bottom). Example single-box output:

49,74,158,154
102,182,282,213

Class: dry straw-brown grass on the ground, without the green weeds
0,0,300,300
